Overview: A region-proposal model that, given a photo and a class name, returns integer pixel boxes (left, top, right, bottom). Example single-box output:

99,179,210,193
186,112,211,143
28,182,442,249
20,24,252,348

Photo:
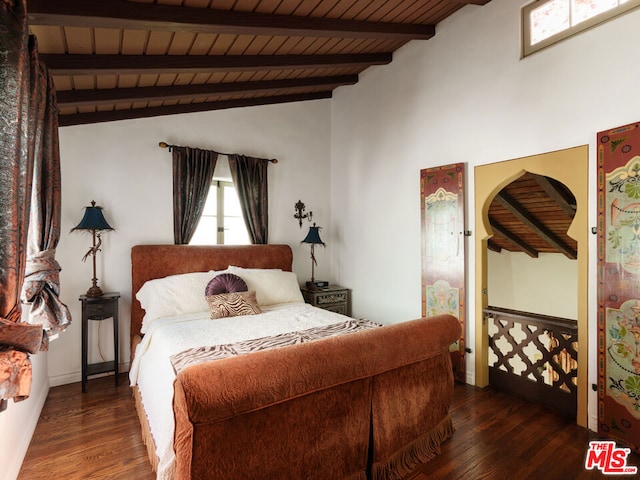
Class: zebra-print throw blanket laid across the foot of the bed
169,318,382,375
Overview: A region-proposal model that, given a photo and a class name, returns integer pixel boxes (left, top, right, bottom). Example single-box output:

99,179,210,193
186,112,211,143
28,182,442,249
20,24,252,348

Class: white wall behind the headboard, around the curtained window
49,100,334,385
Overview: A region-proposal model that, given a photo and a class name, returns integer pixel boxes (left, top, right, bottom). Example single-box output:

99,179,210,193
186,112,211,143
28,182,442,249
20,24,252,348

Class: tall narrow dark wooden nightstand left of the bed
80,292,120,393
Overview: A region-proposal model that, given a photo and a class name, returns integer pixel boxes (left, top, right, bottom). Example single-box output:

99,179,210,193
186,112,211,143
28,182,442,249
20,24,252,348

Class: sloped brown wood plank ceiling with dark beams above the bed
27,0,490,126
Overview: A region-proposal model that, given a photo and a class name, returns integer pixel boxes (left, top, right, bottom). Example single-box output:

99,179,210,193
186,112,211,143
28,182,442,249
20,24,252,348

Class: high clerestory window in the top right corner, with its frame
522,0,640,57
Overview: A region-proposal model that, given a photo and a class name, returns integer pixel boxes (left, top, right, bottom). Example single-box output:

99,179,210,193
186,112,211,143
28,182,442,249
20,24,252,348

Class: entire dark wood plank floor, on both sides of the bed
18,375,640,480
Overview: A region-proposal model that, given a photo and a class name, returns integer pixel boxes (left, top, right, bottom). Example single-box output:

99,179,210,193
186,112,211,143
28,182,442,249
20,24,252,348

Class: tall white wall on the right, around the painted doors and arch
331,0,640,434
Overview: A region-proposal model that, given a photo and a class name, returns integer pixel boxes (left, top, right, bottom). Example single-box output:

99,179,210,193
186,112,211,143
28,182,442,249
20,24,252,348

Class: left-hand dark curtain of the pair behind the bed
171,147,218,245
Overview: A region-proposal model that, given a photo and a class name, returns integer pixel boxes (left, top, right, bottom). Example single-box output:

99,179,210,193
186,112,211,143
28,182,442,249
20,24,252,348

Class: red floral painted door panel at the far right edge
598,123,640,451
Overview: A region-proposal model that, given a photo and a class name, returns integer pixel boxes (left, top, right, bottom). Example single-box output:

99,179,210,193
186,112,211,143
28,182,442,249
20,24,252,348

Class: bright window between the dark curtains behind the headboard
189,180,251,245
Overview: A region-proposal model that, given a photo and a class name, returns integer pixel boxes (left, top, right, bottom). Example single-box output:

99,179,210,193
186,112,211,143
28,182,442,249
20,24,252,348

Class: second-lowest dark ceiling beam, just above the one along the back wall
57,75,358,108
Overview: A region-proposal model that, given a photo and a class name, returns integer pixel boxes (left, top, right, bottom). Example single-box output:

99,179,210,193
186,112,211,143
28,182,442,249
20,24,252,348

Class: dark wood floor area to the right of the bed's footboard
405,385,640,480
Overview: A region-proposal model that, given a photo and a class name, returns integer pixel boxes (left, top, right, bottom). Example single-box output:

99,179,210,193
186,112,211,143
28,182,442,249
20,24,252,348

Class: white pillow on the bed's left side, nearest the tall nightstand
136,271,220,333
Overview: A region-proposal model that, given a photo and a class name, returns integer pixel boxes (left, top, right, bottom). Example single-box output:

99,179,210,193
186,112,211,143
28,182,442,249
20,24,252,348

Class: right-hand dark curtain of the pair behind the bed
229,154,269,244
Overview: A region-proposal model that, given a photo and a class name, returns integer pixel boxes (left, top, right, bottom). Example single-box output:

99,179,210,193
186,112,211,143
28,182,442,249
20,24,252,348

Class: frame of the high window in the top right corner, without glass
522,0,640,57
